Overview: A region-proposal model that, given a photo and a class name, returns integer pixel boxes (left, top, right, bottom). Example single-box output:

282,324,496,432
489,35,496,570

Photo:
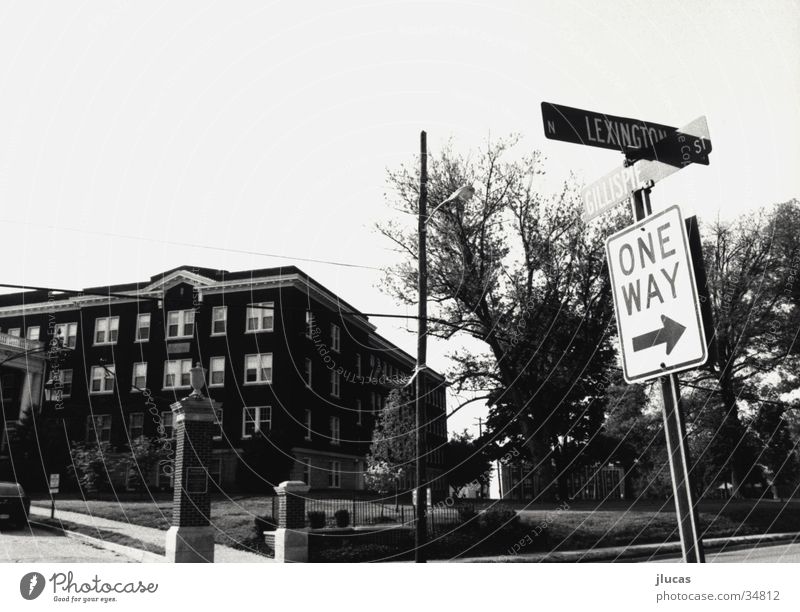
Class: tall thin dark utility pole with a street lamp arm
414,131,428,563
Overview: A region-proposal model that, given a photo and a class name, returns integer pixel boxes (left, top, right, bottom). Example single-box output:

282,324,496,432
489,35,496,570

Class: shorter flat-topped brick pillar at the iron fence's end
274,480,309,563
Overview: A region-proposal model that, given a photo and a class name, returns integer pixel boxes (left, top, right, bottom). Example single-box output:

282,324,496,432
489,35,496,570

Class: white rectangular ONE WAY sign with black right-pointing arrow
606,206,708,383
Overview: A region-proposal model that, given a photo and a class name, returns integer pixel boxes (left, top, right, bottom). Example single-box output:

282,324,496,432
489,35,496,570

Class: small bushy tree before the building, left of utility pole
364,389,417,494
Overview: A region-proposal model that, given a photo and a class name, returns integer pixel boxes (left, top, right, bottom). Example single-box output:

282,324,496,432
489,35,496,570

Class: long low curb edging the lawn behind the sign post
453,532,800,563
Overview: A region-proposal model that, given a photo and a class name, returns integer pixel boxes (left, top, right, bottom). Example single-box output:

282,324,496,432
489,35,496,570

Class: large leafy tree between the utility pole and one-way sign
379,137,619,497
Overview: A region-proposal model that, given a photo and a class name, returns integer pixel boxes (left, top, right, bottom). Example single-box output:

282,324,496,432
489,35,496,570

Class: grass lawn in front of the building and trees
33,495,800,552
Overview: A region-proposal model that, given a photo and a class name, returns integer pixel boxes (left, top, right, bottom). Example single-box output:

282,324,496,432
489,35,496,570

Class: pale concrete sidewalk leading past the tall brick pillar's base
31,505,272,563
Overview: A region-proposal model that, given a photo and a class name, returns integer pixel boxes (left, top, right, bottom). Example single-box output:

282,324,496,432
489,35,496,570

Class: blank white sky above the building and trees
0,0,800,430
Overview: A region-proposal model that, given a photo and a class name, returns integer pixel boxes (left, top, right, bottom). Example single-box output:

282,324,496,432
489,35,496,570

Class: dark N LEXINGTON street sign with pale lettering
542,102,677,155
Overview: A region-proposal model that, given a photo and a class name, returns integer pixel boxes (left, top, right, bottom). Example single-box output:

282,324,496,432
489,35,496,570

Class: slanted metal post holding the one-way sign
633,184,705,563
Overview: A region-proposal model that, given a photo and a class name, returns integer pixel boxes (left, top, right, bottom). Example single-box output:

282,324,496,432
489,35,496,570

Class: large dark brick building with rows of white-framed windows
0,266,447,496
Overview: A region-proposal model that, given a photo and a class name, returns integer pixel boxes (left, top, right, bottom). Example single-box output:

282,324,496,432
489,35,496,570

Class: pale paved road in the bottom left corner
0,527,130,563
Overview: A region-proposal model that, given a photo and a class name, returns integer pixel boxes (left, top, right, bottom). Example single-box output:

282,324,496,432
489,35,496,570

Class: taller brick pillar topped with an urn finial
166,364,217,563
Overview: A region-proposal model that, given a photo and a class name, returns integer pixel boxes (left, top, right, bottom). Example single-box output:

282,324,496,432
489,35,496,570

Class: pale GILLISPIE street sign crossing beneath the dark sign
581,117,711,221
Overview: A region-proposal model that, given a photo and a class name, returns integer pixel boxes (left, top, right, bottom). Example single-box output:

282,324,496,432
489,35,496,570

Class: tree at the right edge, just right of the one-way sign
693,200,800,496
